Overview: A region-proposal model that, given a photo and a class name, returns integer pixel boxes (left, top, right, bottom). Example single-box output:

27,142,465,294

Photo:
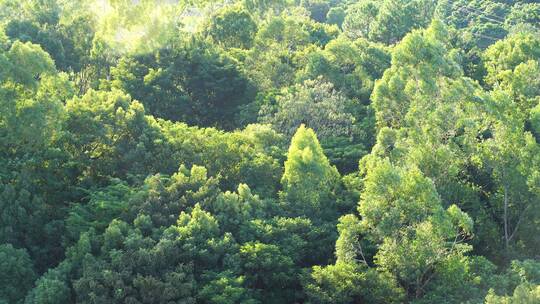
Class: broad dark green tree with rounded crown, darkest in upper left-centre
112,40,252,129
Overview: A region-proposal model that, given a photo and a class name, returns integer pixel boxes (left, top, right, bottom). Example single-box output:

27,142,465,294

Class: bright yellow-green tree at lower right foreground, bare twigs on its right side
360,161,473,299
